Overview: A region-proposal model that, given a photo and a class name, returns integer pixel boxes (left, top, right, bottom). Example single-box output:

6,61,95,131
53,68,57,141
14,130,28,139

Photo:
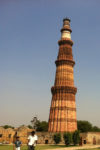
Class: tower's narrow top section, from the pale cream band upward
61,18,72,39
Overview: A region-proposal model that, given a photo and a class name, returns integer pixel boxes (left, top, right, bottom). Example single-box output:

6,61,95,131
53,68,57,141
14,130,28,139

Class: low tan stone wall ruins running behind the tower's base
0,126,100,145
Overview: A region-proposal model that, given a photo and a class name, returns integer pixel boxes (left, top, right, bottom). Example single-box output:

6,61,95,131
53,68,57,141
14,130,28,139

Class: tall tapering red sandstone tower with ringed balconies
48,18,77,132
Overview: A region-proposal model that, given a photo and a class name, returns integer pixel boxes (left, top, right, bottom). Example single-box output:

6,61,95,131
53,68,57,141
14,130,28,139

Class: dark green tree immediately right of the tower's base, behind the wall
77,121,92,132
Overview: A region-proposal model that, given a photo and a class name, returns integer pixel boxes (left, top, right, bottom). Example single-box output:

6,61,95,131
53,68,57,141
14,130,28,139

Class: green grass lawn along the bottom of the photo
0,145,100,150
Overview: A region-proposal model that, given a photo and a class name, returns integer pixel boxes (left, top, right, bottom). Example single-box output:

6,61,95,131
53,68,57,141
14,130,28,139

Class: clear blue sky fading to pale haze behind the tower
0,0,100,127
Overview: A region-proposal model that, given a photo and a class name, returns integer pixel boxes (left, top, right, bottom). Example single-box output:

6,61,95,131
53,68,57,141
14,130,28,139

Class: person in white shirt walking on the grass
28,131,38,150
